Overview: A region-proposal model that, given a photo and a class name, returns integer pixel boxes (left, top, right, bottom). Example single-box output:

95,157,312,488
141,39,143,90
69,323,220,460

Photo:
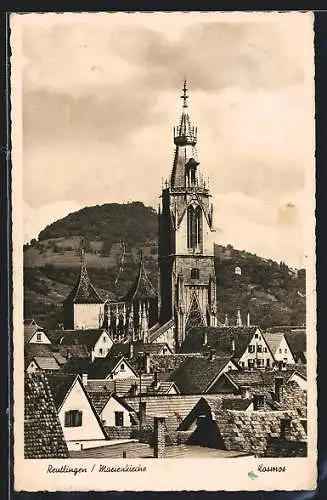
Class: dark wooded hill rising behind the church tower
24,202,305,327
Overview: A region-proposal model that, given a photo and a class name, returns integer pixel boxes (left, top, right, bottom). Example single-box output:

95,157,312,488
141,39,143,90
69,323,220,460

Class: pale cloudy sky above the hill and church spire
20,13,314,267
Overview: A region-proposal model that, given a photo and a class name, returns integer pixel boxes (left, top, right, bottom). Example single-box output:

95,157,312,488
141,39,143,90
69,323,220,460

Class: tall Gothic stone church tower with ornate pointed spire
159,81,217,347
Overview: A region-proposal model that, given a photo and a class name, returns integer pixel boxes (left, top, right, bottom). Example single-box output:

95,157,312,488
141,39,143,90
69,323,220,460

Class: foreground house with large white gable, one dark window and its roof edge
48,373,107,449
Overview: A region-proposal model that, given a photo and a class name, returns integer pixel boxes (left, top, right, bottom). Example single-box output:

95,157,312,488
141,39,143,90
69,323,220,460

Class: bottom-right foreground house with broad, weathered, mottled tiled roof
178,396,307,456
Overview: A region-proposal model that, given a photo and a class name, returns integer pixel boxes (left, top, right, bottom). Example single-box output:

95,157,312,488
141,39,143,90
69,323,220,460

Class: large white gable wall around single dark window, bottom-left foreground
59,379,105,441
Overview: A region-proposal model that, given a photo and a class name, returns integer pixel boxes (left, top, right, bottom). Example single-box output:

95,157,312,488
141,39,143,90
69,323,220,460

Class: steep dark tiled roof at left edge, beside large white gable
24,373,69,459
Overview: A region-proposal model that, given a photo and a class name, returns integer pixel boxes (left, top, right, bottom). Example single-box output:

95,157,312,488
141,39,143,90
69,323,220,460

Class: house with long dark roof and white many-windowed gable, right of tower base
181,326,274,368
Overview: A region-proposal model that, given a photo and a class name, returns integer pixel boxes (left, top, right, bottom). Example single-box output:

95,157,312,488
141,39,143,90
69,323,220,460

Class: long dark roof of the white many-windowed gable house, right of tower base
181,326,257,359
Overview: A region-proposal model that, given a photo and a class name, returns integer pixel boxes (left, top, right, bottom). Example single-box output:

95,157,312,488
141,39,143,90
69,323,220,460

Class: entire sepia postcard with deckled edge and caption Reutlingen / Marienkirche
10,12,317,491
